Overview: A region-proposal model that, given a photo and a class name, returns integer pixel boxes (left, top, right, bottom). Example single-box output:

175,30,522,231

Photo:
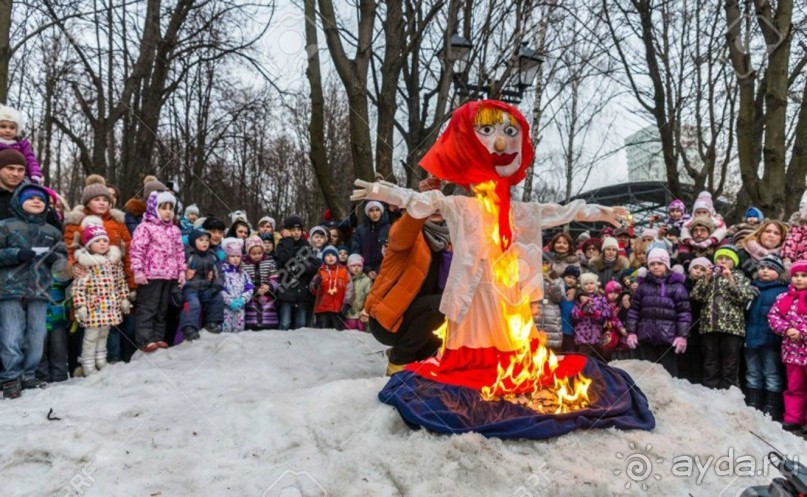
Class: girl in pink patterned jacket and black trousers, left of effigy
129,188,185,352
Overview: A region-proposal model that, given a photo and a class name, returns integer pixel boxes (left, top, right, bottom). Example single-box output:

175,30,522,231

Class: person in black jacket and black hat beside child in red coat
275,216,320,330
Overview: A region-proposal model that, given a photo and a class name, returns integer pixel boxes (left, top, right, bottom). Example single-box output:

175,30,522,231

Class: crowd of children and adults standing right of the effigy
534,192,807,436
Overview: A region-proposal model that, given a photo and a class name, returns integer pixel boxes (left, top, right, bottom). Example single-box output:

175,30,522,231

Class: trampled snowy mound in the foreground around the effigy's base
0,330,807,497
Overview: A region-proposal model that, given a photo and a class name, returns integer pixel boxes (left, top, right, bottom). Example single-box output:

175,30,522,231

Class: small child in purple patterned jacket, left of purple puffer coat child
572,273,611,361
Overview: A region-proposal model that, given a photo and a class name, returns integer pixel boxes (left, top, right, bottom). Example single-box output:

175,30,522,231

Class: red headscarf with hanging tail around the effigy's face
420,100,534,251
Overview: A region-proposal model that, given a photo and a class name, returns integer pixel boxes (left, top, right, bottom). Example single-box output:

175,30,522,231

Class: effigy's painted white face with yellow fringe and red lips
474,108,522,178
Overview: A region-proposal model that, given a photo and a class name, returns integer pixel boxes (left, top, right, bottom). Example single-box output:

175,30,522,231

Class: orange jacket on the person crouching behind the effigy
364,213,432,332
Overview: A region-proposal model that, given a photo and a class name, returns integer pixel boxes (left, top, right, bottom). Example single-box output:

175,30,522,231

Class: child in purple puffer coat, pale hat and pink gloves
627,248,692,376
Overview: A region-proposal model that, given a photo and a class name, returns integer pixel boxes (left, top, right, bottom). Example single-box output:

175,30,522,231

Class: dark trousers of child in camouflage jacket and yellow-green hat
701,333,745,388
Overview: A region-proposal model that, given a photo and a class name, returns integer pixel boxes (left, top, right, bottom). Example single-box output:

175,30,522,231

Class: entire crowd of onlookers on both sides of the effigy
0,100,807,433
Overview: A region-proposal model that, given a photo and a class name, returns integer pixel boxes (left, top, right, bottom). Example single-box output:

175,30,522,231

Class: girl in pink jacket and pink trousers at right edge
768,260,807,436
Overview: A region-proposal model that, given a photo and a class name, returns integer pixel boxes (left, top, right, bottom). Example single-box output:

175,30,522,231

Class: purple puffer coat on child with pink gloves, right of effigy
627,272,692,345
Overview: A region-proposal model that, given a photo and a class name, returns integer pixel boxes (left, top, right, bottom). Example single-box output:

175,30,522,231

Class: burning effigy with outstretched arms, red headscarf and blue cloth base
352,100,655,439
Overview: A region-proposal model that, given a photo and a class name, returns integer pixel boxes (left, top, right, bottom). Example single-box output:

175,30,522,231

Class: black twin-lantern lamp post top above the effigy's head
445,34,543,103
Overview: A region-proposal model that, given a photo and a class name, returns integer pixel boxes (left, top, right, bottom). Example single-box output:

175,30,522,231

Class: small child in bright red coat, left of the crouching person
309,245,353,331
